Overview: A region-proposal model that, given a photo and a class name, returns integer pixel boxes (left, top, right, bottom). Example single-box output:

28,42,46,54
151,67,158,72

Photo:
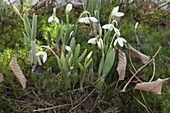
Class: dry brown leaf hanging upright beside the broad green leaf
116,49,127,80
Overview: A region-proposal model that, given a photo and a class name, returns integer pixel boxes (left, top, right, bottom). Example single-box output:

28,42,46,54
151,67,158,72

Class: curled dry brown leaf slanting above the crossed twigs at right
126,43,150,64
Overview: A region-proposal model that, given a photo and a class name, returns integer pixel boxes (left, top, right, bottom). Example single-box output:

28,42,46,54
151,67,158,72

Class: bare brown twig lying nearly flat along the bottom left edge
33,104,71,112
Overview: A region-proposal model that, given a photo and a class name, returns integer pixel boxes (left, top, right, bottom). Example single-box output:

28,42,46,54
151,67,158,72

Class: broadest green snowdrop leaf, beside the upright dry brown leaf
102,48,115,76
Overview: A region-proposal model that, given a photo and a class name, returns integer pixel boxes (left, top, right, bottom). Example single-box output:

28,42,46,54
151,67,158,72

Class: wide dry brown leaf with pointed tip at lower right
135,78,169,94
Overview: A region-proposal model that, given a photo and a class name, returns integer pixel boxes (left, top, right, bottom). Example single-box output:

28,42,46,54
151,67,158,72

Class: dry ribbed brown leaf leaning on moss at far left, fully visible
9,57,27,89
